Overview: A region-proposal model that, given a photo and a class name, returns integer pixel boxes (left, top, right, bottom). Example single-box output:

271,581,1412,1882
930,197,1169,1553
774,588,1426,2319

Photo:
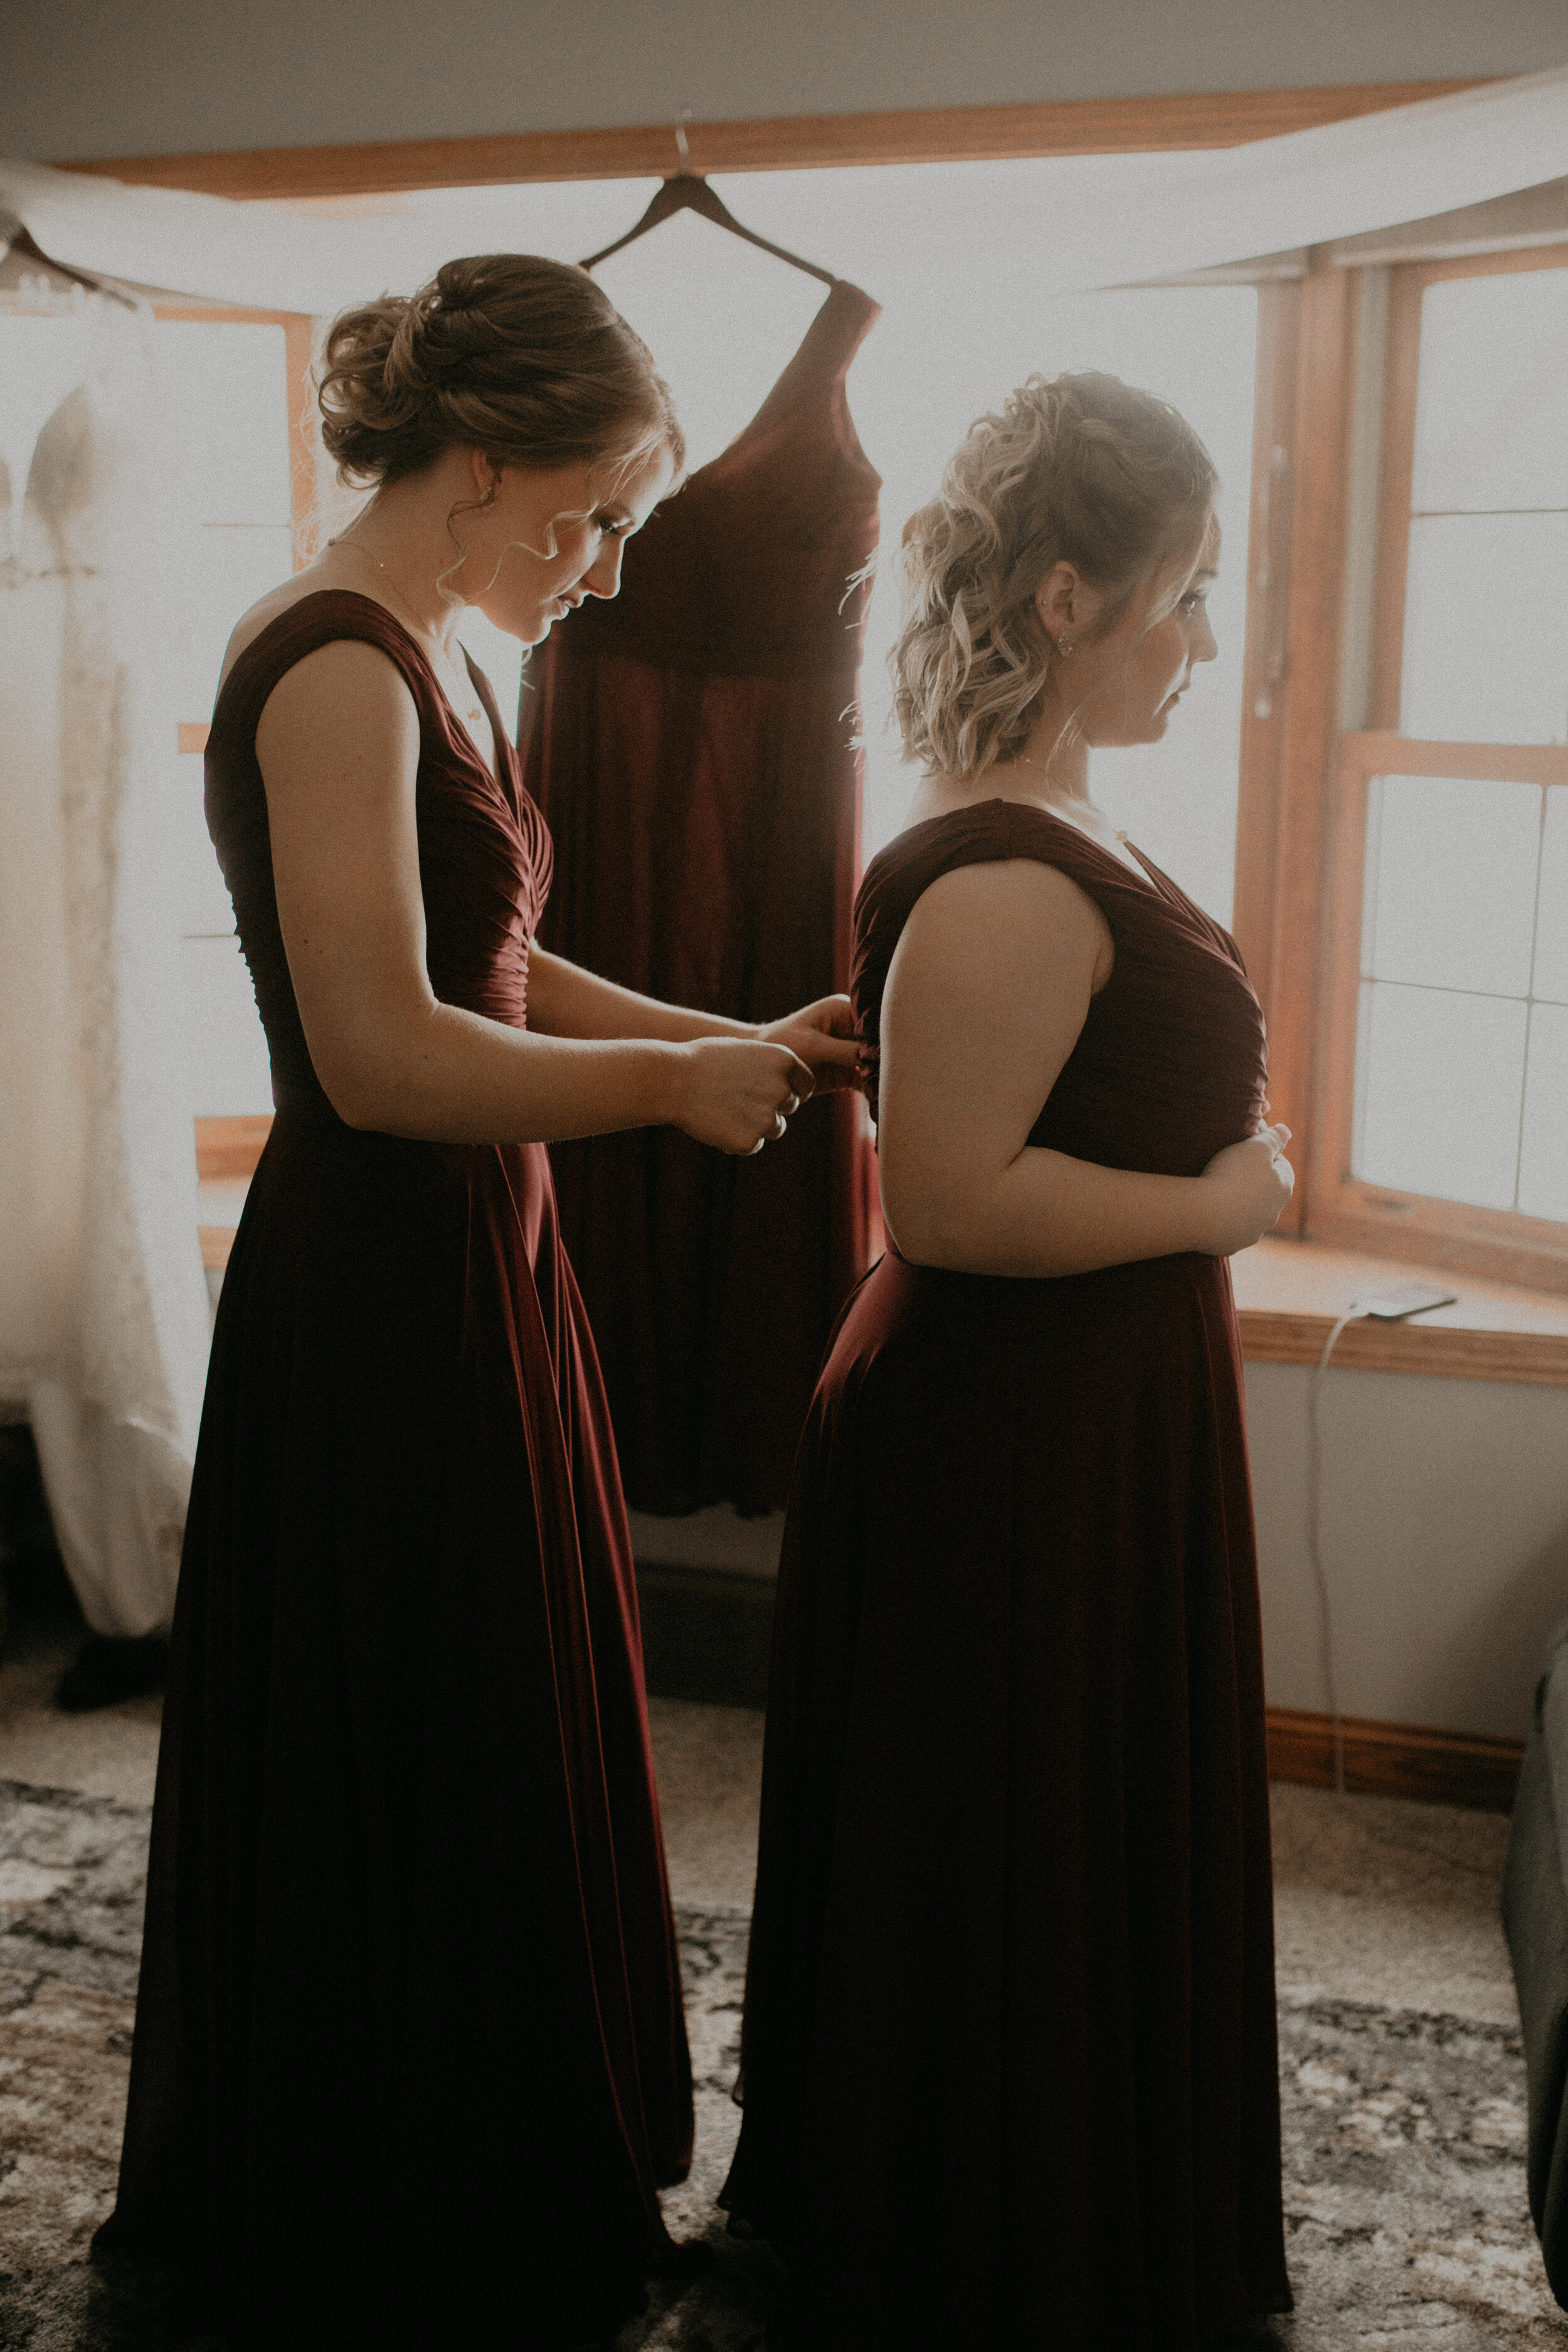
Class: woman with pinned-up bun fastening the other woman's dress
98,254,858,2352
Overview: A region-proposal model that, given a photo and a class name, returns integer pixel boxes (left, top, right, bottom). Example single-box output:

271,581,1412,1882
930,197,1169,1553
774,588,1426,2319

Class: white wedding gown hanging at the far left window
0,297,209,1634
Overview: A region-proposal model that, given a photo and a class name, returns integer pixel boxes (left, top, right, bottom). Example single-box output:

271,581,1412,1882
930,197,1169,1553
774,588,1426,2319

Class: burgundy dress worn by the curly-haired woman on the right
724,800,1291,2352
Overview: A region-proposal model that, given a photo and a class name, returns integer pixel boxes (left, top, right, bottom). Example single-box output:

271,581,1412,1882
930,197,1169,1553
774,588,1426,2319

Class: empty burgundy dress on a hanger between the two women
522,282,882,1512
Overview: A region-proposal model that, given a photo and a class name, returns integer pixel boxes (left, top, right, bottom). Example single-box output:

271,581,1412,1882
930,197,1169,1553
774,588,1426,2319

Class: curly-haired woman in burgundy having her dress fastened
724,374,1291,2352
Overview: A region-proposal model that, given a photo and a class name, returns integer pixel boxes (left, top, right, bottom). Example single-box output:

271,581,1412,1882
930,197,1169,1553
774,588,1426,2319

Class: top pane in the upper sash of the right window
1411,270,1568,515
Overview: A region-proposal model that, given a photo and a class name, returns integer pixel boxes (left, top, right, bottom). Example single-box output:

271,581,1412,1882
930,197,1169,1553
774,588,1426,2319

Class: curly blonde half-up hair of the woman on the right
891,374,1218,776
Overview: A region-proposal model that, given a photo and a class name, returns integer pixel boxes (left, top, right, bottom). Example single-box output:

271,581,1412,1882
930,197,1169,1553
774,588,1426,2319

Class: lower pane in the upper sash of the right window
1399,515,1568,743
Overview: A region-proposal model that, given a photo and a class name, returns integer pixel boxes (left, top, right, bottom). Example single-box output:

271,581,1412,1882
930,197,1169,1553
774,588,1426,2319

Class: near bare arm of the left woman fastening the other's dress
257,640,811,1153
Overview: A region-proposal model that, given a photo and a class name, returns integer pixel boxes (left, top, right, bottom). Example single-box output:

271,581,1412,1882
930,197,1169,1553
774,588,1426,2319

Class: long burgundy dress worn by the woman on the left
103,590,691,2352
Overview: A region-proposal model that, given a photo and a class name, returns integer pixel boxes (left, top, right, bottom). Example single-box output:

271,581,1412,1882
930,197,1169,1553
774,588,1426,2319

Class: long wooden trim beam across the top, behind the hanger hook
59,80,1481,198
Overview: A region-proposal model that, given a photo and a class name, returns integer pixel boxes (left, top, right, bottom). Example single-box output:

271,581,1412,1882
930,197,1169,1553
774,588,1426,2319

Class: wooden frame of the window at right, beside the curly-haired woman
1234,245,1568,1294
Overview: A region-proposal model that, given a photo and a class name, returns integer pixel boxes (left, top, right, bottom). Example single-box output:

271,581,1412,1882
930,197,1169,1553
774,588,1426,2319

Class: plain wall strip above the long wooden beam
0,0,1568,160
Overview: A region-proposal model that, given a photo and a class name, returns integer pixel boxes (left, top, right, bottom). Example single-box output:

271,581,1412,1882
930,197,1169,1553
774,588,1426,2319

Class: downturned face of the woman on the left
452,449,675,645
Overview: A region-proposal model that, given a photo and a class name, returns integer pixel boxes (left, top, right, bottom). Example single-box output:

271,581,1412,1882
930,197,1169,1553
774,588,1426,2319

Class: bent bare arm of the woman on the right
877,859,1291,1275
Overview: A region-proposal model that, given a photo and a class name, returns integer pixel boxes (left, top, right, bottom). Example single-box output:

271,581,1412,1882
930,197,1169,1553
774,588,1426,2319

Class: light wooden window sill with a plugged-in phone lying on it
198,1176,1568,1388
